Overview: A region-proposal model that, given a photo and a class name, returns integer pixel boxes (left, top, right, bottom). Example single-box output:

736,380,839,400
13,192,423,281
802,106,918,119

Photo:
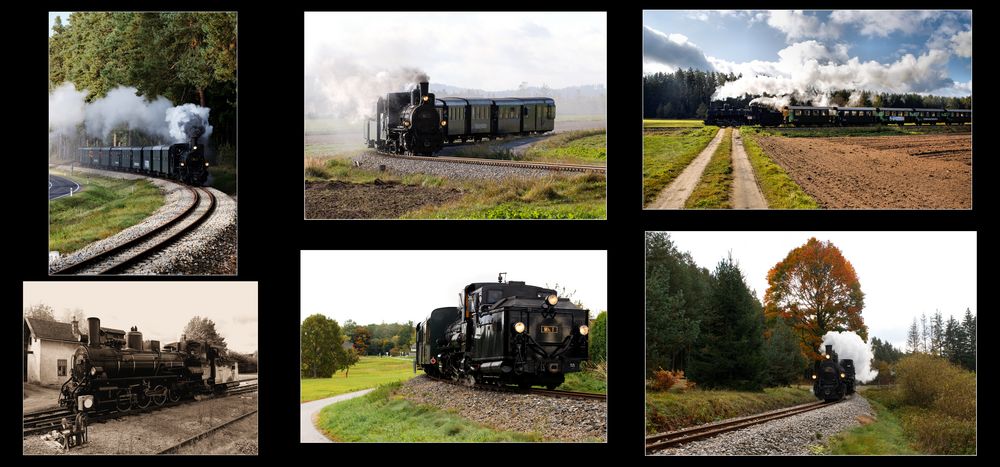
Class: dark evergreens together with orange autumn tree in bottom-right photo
646,232,867,389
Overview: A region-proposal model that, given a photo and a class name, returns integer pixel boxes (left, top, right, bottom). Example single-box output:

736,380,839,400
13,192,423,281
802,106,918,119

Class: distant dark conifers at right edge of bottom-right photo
906,308,978,371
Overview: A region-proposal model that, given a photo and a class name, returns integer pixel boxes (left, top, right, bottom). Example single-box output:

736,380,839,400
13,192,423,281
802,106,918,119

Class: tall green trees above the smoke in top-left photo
49,12,236,145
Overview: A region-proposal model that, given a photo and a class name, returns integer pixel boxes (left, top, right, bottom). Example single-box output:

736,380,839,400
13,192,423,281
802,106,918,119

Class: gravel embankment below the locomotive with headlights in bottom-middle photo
397,376,608,442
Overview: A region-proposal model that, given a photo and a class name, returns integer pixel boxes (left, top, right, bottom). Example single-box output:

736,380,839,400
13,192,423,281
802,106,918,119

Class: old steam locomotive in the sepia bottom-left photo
59,318,239,412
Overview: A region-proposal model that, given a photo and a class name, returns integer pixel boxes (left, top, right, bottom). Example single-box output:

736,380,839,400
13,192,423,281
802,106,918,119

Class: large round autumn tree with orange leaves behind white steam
764,238,868,360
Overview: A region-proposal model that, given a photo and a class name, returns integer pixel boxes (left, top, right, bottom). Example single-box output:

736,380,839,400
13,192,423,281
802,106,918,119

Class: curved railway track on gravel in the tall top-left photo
52,187,216,275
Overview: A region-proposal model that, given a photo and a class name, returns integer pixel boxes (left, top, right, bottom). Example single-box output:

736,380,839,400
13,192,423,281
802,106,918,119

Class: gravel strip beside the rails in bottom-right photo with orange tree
654,394,874,456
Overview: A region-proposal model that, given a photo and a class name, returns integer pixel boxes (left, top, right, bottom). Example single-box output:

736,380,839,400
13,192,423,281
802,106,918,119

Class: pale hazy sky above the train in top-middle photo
305,12,607,91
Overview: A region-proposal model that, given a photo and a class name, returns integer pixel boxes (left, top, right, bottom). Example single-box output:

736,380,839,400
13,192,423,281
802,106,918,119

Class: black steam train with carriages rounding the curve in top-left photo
78,126,208,186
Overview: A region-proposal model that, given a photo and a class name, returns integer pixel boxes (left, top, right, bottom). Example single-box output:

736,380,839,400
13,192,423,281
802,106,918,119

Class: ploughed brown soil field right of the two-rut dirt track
757,134,972,209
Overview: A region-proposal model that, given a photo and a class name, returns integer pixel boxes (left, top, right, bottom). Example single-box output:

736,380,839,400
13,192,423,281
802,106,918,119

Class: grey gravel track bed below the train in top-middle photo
354,152,555,180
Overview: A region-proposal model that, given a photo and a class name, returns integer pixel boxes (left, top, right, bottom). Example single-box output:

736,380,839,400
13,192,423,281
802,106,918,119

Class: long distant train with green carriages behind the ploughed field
705,105,972,126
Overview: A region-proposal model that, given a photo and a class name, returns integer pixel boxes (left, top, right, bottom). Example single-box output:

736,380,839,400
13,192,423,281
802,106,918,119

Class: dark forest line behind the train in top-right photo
642,69,972,118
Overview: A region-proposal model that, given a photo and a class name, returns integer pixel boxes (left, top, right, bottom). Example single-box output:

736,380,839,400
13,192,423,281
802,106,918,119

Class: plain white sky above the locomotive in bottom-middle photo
300,250,608,324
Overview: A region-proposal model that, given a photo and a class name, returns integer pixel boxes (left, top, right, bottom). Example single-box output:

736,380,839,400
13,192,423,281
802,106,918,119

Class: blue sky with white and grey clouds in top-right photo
643,10,972,97
